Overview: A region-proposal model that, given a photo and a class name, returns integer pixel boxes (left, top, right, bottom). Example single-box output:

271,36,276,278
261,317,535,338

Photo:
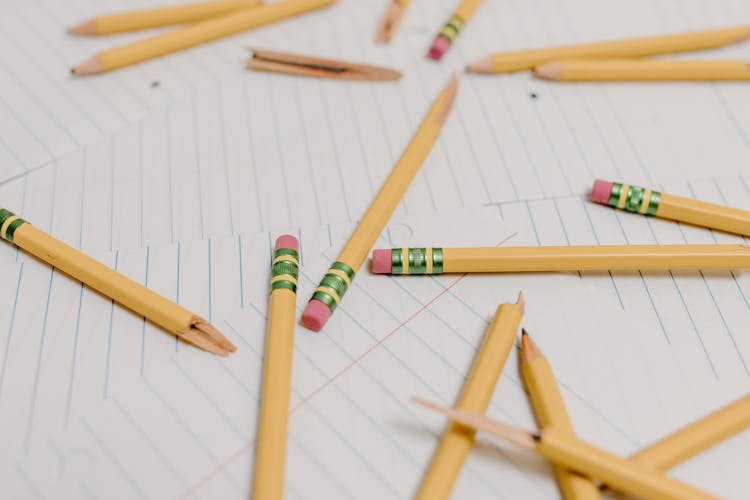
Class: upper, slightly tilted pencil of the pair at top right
467,26,750,73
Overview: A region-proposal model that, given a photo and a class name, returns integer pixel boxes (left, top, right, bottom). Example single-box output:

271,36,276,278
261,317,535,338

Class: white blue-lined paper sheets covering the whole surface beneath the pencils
0,0,750,499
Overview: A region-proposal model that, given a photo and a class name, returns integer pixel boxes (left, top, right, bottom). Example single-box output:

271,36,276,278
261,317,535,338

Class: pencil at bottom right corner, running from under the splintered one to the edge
631,396,750,469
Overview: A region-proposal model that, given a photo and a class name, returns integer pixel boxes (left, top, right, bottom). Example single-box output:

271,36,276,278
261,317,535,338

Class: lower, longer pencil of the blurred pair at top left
71,0,336,75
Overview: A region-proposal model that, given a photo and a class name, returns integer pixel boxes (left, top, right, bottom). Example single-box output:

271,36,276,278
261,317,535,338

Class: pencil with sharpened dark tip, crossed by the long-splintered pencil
521,330,601,500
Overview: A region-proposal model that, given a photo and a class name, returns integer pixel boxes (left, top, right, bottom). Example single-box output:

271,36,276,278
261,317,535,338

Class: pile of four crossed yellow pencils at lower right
415,304,750,500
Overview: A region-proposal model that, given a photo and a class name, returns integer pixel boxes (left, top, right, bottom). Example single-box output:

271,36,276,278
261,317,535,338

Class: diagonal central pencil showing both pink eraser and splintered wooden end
302,76,458,332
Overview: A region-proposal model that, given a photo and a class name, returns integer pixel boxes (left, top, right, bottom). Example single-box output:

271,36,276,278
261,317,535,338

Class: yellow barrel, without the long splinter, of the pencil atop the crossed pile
537,427,715,500
